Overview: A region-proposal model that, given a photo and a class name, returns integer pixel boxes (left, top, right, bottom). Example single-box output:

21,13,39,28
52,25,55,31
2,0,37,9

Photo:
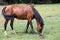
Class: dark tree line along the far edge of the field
0,0,60,4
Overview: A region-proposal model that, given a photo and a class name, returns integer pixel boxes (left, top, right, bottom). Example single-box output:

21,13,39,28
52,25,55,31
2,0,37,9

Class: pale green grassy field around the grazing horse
0,4,60,40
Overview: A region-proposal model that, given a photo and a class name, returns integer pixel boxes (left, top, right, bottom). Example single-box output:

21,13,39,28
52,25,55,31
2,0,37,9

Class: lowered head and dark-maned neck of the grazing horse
34,9,44,35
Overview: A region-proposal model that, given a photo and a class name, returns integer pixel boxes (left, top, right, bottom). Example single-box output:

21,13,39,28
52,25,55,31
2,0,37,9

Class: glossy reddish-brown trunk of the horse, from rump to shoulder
2,5,34,19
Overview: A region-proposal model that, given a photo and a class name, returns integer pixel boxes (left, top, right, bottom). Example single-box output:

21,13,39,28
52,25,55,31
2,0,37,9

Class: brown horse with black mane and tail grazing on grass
2,4,44,35
